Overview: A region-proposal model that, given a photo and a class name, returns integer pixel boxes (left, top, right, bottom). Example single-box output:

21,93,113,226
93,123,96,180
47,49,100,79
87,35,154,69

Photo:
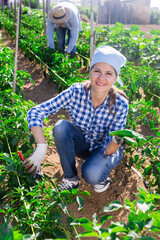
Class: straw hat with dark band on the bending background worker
48,5,71,23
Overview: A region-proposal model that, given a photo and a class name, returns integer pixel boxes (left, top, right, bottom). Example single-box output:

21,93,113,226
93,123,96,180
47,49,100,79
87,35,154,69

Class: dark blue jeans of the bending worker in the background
56,26,76,58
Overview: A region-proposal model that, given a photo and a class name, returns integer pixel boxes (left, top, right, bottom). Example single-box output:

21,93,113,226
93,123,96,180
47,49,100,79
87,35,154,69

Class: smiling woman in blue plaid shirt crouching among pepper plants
23,46,128,192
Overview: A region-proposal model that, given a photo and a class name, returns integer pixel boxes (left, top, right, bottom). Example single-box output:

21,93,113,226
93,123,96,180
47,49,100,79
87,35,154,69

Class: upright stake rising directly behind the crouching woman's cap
90,0,94,61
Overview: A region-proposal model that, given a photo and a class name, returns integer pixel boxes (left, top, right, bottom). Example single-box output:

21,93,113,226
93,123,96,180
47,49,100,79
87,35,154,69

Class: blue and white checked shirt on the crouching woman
27,83,128,151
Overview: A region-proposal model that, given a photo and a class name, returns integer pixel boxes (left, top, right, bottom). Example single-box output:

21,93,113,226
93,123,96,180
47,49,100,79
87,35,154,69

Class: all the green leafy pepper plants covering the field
0,7,160,240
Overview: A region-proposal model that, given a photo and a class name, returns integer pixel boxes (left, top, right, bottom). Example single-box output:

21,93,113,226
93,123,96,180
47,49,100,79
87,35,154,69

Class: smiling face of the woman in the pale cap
90,62,117,92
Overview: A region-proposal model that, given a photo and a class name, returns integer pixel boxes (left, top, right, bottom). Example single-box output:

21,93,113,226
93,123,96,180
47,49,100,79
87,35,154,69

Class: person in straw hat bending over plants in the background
47,2,82,58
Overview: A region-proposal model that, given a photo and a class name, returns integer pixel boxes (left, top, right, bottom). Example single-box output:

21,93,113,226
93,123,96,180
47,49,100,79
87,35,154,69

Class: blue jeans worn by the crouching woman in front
53,120,123,185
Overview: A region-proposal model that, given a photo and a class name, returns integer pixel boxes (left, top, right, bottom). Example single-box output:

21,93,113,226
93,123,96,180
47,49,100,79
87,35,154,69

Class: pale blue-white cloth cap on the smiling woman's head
90,46,126,86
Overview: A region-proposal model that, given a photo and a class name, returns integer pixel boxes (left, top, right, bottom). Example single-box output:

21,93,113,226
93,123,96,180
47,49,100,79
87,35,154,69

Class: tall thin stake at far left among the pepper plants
13,0,21,103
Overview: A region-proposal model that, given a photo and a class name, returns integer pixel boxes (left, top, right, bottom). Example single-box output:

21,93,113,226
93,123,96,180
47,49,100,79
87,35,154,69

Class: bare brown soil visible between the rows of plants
1,25,159,240
